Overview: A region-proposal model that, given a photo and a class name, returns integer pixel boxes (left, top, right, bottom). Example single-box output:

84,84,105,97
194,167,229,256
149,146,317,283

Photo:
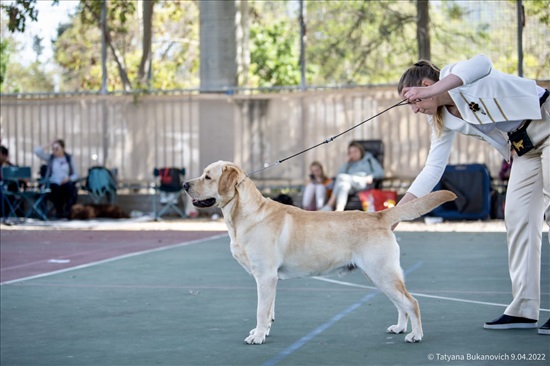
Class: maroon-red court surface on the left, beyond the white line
0,229,223,283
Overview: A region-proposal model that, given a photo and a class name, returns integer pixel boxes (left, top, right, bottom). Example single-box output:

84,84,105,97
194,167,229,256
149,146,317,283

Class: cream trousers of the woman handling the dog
504,99,550,320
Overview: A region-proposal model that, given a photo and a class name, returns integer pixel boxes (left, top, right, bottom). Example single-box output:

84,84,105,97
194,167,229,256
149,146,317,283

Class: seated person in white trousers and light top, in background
321,141,384,211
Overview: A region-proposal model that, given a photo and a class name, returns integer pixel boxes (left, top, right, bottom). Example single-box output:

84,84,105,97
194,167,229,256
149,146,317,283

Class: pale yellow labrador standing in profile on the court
184,161,456,344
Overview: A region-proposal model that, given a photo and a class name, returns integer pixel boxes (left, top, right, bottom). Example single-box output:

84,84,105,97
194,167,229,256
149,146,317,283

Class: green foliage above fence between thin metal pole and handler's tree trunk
306,0,416,85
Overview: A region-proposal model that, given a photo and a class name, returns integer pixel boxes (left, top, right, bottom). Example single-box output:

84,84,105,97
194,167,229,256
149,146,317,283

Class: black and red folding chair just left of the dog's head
153,167,187,220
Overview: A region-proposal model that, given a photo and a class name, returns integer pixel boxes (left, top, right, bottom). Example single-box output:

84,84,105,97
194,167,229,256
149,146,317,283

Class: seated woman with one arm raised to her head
34,139,78,219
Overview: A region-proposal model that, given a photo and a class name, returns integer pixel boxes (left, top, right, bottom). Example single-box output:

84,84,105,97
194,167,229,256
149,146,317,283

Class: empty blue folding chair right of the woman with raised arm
81,166,117,204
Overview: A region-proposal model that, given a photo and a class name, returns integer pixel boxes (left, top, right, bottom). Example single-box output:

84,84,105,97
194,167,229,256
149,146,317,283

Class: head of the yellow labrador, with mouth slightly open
183,161,246,208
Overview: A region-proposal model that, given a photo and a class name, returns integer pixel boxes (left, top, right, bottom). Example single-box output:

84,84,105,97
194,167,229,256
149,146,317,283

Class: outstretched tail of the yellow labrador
380,190,456,226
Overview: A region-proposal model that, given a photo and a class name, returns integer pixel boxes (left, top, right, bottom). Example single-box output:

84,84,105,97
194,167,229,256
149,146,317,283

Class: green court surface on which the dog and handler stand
0,232,550,366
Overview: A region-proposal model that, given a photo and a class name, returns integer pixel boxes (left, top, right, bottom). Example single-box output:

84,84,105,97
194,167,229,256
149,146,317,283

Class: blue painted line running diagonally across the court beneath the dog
262,261,423,366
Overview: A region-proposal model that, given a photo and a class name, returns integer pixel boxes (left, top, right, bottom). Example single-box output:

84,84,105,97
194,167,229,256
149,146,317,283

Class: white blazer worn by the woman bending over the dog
408,55,542,197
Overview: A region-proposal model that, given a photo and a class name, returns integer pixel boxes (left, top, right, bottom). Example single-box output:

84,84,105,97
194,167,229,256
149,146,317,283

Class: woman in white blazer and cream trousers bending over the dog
398,55,550,334
